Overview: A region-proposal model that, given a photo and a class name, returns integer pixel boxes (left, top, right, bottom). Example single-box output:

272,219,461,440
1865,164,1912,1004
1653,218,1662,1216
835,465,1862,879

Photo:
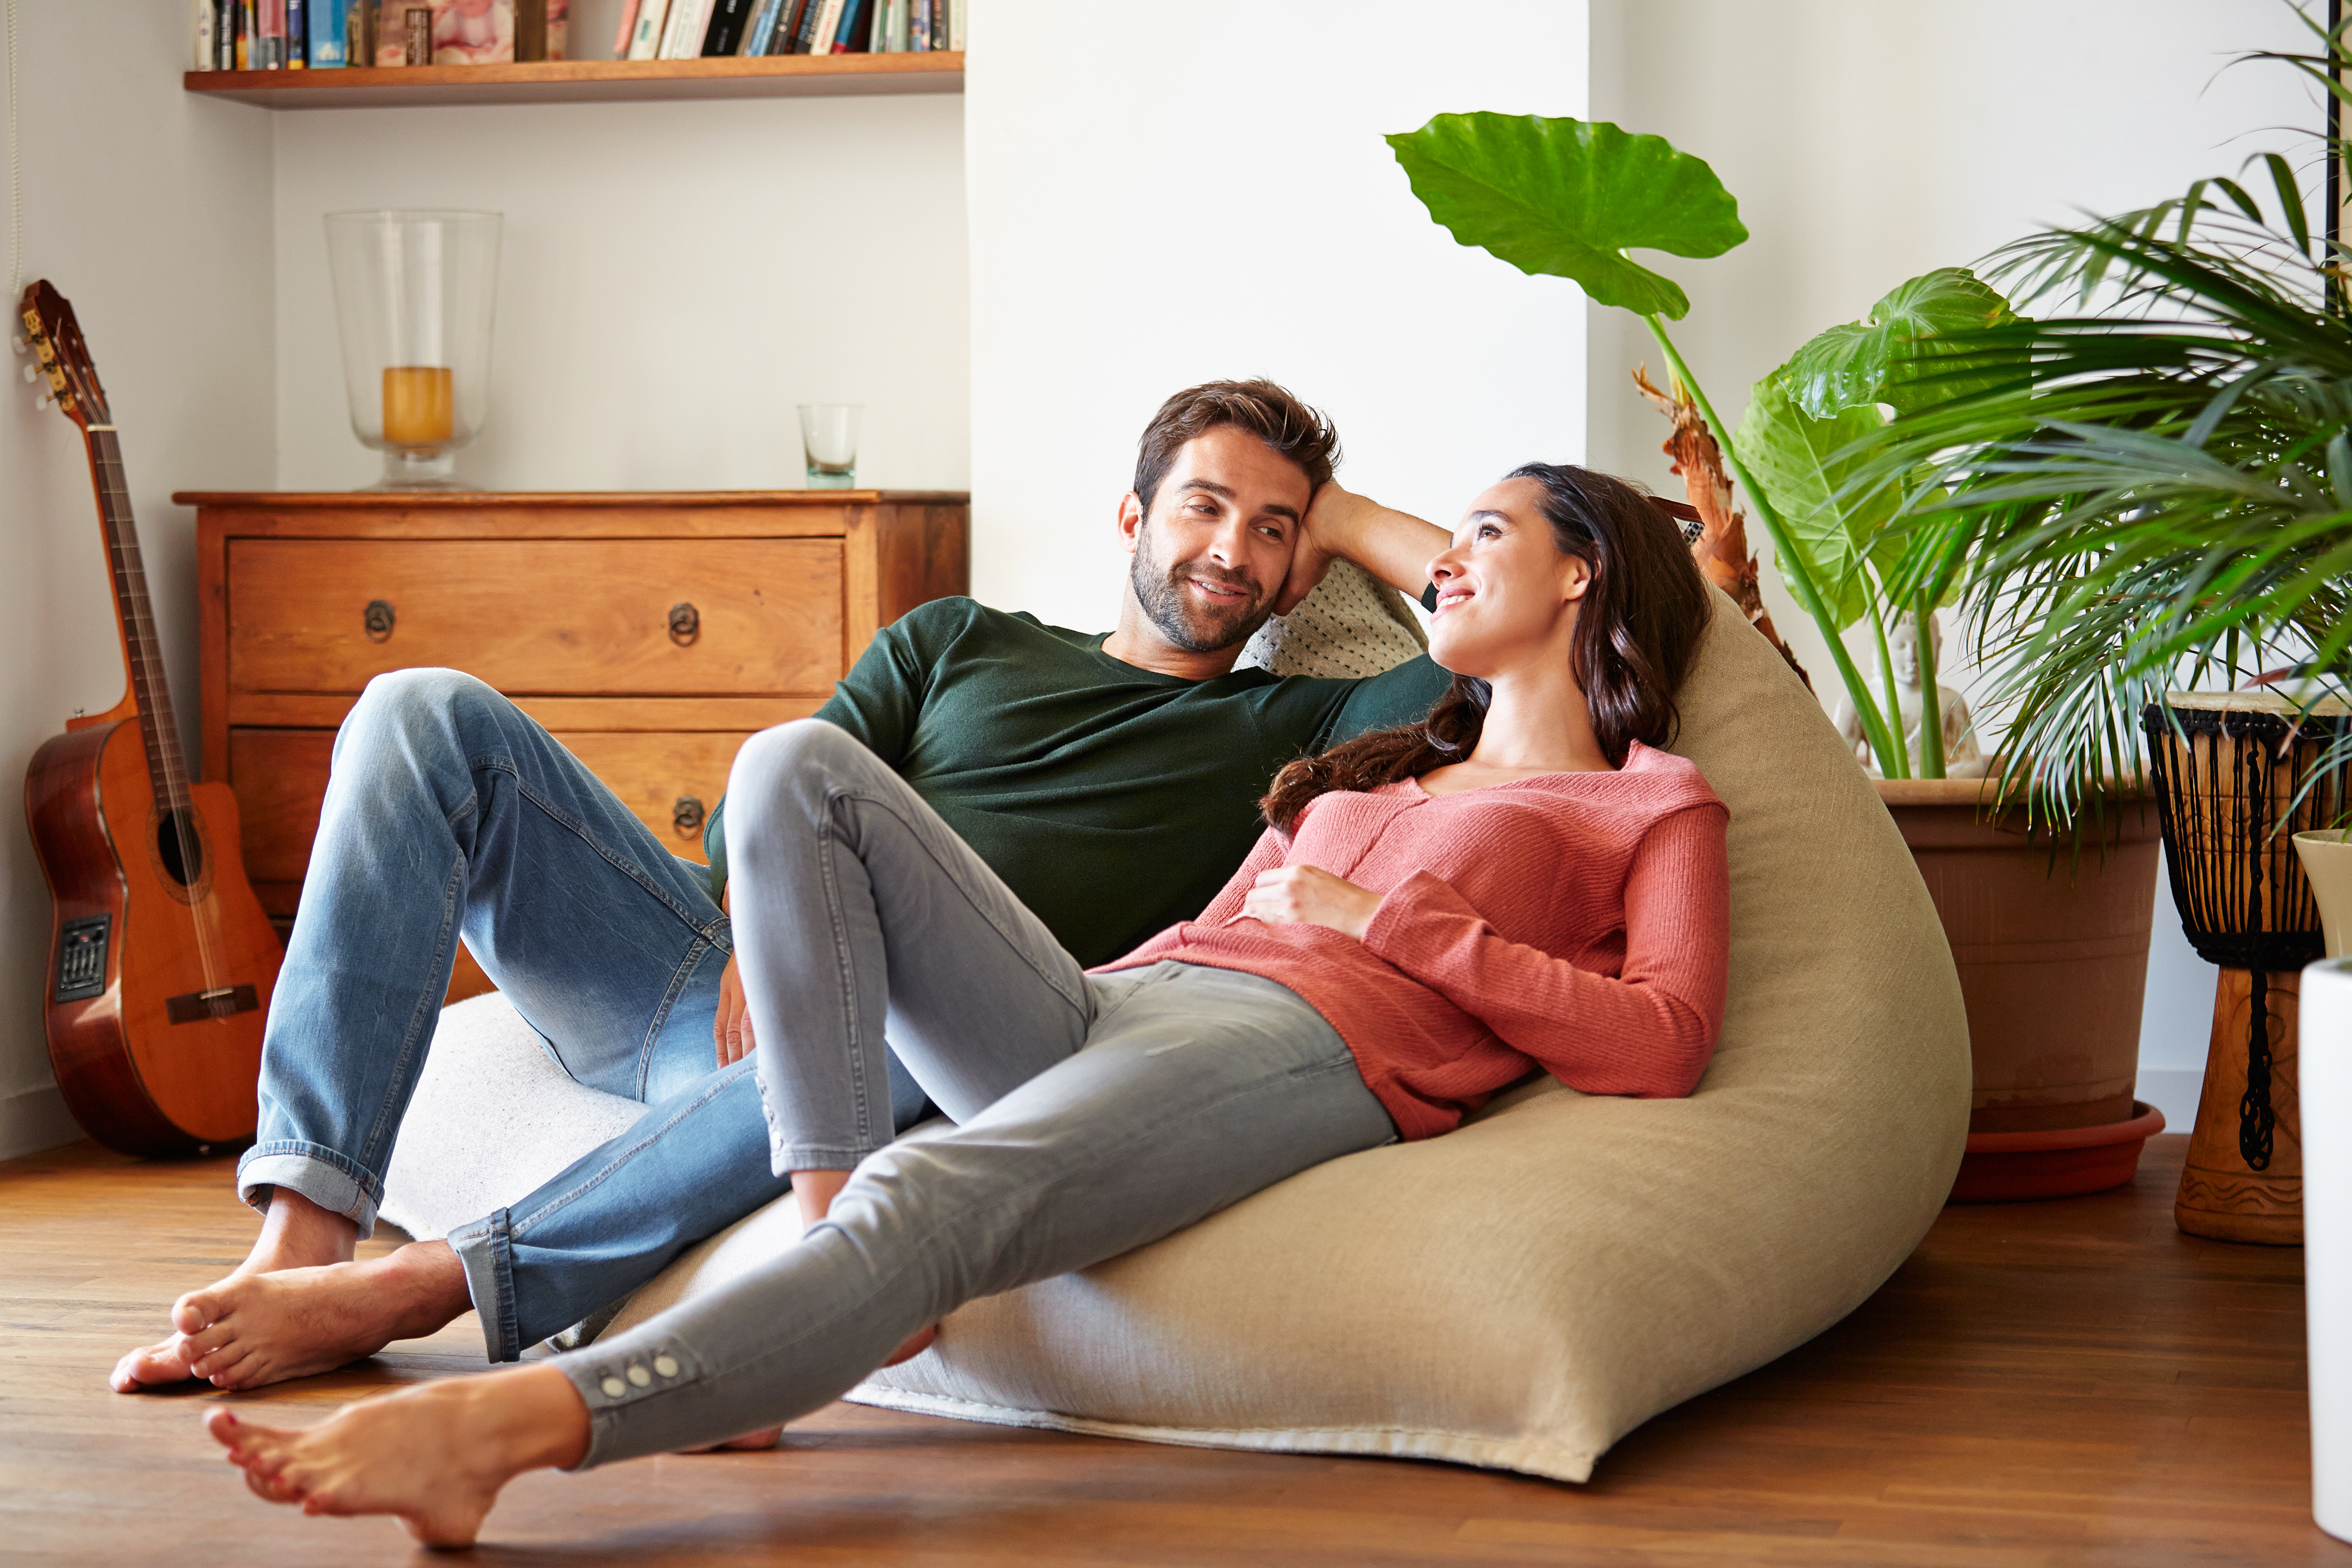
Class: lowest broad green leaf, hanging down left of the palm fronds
1738,372,1900,630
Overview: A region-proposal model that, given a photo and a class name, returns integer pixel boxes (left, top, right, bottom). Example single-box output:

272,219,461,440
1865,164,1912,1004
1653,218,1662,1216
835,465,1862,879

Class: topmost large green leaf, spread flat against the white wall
1388,113,1748,317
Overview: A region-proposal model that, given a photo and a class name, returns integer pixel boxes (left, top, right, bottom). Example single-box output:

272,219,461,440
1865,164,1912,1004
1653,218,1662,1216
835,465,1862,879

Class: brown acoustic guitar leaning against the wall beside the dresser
21,282,280,1154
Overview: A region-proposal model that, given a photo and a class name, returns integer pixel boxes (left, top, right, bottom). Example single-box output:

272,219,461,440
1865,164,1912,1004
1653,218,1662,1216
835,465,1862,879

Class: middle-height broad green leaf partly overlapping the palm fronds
1778,266,2018,419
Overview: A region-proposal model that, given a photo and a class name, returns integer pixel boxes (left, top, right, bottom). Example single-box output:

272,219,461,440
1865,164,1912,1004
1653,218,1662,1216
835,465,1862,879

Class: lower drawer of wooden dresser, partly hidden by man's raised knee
228,729,746,919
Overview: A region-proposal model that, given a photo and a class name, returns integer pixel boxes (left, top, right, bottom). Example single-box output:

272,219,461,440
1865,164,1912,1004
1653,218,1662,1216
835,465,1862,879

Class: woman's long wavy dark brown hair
1258,463,1712,832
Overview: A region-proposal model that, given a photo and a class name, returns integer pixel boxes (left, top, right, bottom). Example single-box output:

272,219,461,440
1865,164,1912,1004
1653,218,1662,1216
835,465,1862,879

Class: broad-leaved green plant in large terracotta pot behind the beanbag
1390,115,2161,1196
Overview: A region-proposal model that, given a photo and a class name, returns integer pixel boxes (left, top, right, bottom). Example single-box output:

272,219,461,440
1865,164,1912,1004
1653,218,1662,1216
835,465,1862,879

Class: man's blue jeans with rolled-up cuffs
238,670,922,1359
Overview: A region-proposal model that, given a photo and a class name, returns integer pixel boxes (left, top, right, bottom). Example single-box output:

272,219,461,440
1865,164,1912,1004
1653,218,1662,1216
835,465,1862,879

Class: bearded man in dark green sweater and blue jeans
113,381,1446,1392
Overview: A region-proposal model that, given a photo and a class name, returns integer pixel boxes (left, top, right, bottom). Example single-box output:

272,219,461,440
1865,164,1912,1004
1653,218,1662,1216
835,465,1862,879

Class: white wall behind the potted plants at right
1588,0,2319,1131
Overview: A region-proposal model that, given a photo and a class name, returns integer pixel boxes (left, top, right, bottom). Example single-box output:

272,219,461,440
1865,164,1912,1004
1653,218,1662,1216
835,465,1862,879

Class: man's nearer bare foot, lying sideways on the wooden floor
115,1241,468,1389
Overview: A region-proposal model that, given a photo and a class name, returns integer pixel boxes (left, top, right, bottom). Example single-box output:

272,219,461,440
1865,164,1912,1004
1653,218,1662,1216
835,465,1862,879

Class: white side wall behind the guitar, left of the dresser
0,0,273,1159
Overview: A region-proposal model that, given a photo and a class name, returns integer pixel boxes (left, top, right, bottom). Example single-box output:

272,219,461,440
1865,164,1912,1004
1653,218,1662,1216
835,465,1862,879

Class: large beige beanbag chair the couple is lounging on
381,585,1969,1481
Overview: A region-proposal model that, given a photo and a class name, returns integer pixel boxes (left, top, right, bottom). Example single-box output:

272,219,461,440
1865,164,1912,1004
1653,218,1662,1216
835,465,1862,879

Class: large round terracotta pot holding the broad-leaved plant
1879,778,2159,1161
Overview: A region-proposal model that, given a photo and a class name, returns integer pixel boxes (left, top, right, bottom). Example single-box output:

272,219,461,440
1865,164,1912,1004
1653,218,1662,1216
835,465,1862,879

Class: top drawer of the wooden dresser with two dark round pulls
226,538,844,696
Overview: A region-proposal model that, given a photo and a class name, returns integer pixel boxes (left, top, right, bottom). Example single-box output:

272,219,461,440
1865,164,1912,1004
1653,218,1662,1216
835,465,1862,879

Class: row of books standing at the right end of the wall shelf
612,0,967,59
